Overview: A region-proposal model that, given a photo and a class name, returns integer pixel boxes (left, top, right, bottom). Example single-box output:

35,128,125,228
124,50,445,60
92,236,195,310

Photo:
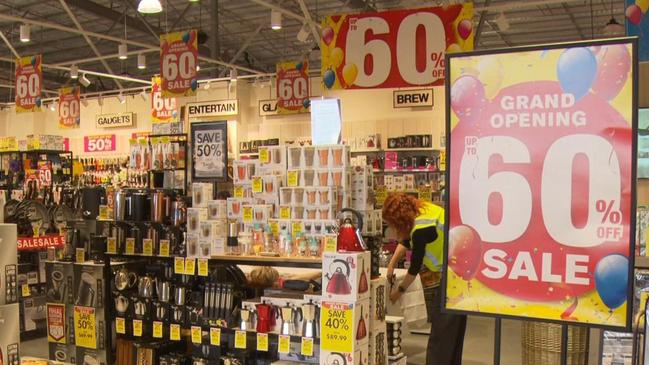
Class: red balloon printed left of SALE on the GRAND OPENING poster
448,226,482,281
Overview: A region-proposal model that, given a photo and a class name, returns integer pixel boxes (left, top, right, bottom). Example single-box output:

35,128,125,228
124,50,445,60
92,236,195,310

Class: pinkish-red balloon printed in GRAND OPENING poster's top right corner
591,44,631,100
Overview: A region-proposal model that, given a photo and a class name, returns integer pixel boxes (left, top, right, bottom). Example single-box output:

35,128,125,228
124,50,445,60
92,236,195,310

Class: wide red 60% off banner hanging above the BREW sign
320,3,473,89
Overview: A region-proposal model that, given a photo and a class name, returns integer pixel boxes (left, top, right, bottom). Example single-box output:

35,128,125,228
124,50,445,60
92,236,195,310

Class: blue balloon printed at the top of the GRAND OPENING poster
557,47,597,100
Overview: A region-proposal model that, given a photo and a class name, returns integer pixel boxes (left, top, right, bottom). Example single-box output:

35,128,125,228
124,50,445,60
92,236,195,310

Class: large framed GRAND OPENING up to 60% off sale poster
444,38,638,329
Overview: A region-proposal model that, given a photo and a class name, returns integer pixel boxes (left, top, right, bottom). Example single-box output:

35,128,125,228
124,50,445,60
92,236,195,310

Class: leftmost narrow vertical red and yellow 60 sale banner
16,55,43,113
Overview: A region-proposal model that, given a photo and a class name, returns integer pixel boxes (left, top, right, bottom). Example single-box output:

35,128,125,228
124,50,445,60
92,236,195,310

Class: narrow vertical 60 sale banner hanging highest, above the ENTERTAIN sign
160,30,198,98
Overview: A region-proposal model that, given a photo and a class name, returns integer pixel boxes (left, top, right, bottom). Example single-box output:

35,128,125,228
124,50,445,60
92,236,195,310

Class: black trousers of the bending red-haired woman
424,285,466,365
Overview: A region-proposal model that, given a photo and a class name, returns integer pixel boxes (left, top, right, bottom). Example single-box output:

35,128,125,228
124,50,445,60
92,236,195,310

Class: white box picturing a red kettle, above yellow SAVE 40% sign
322,252,371,301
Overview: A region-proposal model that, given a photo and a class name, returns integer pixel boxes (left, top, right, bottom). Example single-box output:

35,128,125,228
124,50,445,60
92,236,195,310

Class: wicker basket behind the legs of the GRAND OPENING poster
521,321,588,365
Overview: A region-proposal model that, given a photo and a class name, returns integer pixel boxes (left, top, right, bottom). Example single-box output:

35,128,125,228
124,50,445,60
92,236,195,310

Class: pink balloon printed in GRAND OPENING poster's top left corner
451,75,486,123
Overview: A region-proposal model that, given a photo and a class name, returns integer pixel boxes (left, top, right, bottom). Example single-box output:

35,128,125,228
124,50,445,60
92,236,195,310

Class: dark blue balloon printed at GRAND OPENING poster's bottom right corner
595,254,629,310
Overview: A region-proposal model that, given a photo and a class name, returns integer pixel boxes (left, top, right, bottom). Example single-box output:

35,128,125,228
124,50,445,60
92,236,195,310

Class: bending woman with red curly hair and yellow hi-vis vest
383,193,466,365
